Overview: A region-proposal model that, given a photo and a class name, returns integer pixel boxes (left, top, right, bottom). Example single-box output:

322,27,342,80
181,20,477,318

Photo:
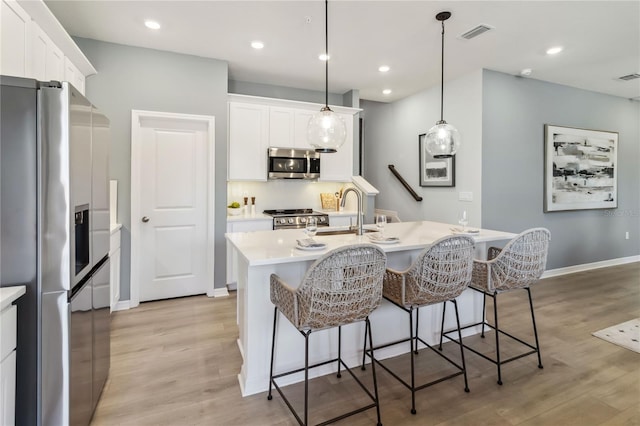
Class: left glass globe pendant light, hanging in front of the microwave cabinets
307,0,347,153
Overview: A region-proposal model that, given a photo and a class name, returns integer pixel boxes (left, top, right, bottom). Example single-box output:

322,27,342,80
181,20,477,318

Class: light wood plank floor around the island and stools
92,263,640,426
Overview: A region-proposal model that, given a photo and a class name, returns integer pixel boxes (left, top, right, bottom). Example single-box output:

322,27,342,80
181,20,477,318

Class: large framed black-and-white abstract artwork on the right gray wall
544,124,618,212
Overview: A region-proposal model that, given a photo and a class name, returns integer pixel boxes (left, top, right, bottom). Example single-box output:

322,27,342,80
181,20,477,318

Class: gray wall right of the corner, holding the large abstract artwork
482,70,640,269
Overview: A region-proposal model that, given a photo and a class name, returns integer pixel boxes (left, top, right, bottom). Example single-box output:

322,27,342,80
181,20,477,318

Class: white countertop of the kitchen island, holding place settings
226,221,516,266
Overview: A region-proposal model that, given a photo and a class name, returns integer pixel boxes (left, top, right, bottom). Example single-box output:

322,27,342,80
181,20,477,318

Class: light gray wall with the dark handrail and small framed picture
360,70,482,226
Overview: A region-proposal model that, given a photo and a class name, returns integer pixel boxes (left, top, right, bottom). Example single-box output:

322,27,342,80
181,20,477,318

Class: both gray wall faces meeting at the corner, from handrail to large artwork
360,70,640,269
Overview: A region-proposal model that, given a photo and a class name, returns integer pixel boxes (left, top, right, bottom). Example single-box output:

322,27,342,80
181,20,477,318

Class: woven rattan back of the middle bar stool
385,235,475,306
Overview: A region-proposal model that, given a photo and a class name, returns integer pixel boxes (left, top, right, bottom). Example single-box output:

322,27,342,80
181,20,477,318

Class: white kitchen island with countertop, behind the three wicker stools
226,221,515,396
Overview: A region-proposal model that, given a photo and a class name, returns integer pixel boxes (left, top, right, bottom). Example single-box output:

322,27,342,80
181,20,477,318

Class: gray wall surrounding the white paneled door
74,38,228,300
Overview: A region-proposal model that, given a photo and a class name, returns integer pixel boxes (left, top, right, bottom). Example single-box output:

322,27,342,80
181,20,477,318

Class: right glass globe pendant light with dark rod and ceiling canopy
426,12,460,158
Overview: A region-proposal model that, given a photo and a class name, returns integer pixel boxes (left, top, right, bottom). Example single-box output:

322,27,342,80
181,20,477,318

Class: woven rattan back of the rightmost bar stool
484,228,551,292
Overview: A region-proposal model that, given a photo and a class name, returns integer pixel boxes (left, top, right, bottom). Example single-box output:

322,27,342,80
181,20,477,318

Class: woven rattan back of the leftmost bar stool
297,244,387,329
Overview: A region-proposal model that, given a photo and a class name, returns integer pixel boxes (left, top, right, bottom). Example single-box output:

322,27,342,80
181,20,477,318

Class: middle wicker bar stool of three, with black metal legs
362,235,475,414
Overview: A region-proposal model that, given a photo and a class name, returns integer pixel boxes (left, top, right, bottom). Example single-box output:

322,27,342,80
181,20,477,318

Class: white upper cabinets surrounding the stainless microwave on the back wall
228,95,360,182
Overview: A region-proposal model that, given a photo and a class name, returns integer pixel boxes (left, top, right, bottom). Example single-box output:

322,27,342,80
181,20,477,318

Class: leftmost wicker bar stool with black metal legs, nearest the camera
267,244,387,426
